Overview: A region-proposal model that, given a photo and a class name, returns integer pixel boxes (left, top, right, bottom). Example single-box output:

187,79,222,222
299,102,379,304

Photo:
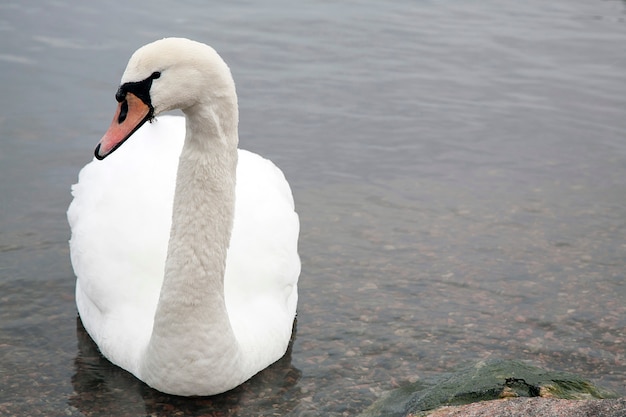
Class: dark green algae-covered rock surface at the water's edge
362,360,616,417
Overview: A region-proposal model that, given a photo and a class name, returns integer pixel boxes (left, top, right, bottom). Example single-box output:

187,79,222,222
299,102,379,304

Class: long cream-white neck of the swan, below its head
142,101,241,394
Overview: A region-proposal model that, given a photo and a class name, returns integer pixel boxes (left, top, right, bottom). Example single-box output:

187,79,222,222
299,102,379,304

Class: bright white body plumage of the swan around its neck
68,39,300,395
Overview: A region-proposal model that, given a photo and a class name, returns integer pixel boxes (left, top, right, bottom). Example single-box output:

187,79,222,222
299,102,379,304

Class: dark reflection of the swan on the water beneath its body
69,317,302,416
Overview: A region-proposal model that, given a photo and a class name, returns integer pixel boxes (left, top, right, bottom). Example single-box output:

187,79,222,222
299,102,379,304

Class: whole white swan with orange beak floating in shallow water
67,38,300,396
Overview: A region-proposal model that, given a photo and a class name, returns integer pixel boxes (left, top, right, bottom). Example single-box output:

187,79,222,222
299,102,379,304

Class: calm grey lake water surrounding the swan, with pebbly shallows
0,0,626,416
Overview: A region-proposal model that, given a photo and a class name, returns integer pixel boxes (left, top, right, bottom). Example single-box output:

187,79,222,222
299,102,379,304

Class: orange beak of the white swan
94,92,152,159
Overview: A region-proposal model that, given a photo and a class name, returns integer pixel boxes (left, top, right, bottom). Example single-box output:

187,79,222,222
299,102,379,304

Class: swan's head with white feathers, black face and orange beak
95,38,237,159
